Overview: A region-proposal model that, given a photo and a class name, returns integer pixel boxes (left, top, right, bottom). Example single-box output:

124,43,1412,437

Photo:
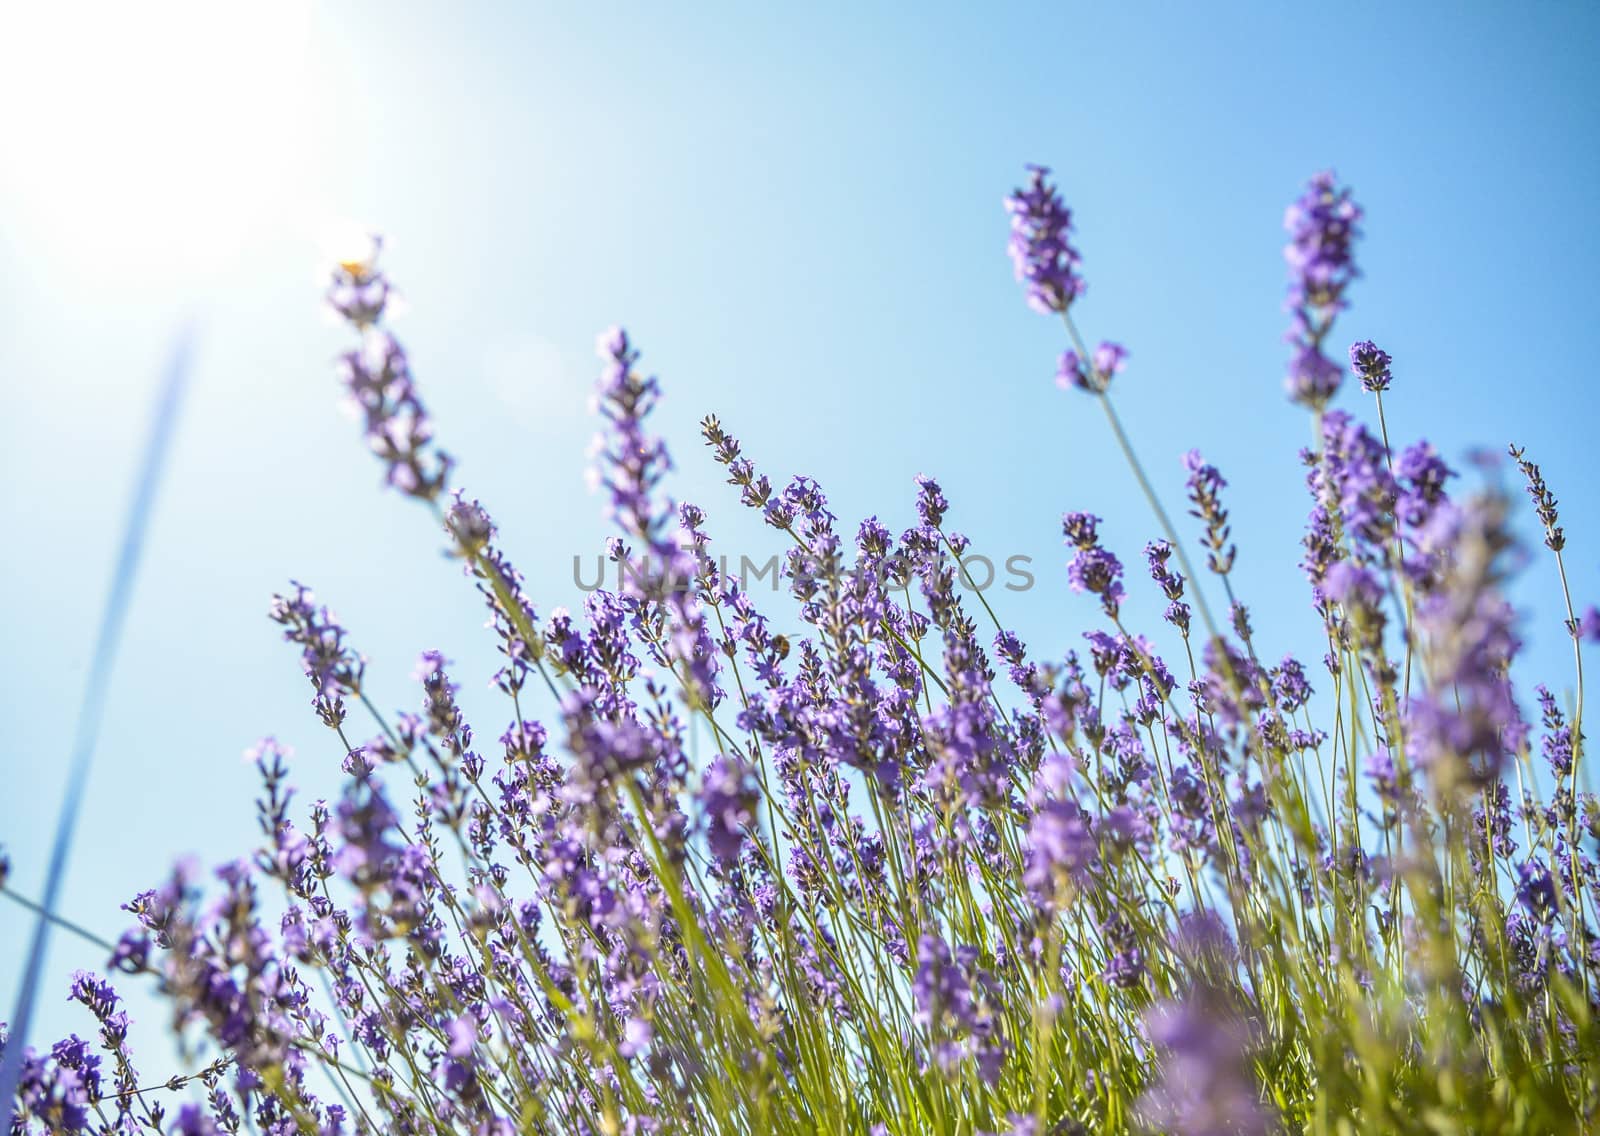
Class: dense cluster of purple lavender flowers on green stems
3,168,1600,1136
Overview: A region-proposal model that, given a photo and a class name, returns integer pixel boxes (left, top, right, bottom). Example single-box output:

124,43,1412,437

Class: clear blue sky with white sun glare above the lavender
0,0,1600,1078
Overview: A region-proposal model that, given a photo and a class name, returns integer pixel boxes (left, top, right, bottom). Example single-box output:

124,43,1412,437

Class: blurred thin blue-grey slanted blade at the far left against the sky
0,323,195,1133
